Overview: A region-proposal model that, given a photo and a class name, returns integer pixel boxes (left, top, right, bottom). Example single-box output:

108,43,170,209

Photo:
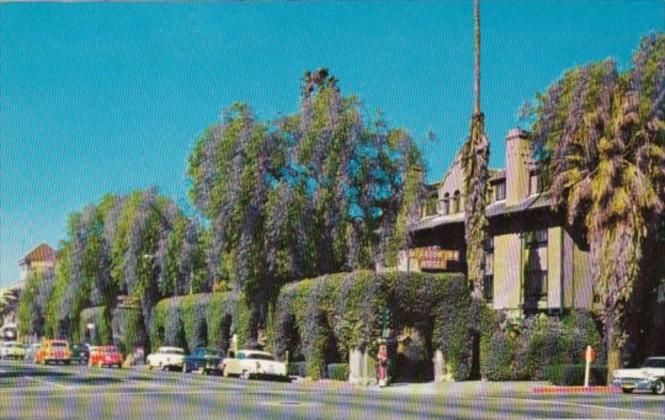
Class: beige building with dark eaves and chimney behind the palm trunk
398,129,593,316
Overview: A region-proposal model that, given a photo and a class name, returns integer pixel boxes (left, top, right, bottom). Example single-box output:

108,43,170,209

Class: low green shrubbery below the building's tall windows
480,308,604,381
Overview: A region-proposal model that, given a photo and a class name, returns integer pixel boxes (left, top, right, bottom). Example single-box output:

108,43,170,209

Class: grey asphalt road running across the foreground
0,360,665,420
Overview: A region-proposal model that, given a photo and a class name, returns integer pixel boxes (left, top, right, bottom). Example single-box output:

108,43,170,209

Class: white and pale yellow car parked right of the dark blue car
223,350,289,380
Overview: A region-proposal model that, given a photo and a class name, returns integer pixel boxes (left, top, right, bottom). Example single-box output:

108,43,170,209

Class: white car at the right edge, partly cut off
612,356,665,395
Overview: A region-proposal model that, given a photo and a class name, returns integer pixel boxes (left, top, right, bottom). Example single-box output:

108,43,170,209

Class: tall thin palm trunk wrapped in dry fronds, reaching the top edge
461,0,489,299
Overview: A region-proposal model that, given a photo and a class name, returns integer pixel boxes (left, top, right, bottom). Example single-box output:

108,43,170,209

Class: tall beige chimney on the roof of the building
506,128,532,206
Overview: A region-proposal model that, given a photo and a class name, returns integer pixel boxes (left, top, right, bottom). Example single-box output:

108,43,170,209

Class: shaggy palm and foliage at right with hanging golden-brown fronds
532,34,665,371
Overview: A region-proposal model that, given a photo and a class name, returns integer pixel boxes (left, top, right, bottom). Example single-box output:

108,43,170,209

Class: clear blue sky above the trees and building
0,0,665,285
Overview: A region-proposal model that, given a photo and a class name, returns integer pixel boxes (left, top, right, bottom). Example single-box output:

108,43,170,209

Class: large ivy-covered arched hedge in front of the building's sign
268,271,471,380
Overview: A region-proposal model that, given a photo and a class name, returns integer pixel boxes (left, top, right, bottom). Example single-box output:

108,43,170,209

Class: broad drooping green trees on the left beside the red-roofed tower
46,188,206,340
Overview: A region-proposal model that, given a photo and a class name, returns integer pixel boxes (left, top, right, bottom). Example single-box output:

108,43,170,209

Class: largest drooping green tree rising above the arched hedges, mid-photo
189,69,422,336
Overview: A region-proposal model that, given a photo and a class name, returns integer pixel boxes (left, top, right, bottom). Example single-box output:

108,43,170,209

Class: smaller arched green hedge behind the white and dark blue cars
150,293,243,352
